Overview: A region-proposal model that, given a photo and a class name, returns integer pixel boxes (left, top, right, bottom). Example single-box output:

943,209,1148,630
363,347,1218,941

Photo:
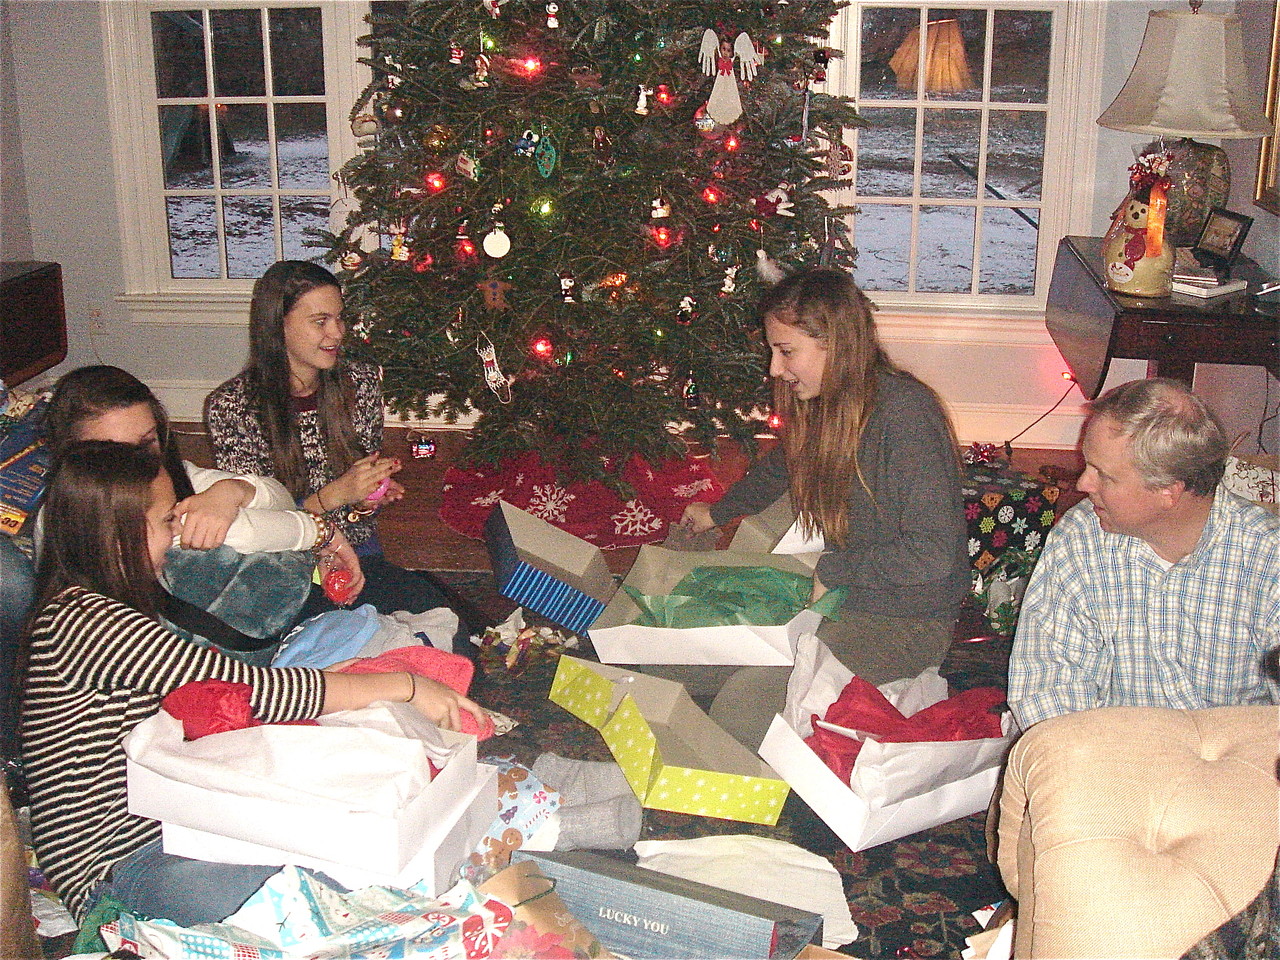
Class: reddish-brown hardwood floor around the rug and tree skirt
174,424,1080,573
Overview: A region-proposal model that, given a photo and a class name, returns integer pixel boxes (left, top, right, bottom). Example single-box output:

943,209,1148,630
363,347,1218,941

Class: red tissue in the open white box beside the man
805,677,1006,783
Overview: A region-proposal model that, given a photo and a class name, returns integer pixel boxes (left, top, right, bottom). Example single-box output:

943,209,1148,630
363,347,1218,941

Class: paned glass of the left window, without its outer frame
151,6,329,279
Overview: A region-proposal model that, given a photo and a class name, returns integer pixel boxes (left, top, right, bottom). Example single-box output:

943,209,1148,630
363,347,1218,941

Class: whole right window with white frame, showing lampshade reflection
827,0,1101,312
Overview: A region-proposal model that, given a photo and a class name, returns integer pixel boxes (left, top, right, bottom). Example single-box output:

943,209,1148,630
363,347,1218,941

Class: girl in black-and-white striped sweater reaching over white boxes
18,442,483,925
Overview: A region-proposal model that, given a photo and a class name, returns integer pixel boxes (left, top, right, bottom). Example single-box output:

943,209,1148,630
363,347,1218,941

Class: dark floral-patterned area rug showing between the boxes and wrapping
436,572,1010,957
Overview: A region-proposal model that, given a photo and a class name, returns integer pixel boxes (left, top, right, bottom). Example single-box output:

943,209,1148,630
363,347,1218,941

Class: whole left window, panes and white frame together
102,0,369,323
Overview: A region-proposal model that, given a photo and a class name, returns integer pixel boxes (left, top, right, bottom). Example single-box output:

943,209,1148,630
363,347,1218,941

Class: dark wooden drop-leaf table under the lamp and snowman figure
1044,237,1280,399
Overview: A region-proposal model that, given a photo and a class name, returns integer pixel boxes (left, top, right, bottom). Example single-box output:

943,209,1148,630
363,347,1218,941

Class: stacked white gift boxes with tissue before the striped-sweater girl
124,704,498,890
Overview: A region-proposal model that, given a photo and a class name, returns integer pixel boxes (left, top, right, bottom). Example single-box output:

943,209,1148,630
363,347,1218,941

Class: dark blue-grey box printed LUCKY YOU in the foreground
511,850,822,960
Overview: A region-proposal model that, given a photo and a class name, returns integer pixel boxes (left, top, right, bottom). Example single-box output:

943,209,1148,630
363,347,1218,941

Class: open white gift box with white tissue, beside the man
759,636,1014,850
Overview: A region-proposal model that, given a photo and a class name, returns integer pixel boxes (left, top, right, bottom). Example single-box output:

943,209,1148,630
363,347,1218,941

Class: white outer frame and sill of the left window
100,0,369,326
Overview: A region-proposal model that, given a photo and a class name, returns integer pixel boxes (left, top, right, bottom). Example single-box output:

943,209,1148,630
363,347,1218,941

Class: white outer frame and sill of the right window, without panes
824,0,1106,330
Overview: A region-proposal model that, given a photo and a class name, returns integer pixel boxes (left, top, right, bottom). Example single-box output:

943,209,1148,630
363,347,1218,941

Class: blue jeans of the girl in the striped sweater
97,840,280,927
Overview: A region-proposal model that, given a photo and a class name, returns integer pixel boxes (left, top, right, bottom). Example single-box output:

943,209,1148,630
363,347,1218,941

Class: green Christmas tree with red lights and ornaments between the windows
326,0,860,481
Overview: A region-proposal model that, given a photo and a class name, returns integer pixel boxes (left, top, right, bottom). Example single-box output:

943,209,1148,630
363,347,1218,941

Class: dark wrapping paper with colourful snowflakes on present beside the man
961,465,1061,573
